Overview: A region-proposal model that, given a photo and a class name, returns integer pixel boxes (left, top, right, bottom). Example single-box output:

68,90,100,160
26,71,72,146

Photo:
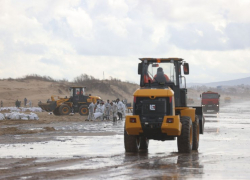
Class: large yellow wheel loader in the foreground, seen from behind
124,58,205,153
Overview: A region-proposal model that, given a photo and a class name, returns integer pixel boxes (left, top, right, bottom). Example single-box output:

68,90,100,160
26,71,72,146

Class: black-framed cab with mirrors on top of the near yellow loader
138,58,189,107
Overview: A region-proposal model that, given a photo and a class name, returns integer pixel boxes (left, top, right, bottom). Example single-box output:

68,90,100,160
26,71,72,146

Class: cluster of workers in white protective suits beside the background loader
86,98,126,121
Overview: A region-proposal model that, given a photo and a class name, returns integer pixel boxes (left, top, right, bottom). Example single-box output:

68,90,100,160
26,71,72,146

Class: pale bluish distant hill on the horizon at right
187,77,250,87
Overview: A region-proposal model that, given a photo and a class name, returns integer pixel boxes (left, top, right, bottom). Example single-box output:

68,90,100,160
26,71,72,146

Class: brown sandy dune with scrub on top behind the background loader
0,75,139,106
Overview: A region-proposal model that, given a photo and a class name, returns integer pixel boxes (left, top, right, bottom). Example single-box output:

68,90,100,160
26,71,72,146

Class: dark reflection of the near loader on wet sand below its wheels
124,151,204,180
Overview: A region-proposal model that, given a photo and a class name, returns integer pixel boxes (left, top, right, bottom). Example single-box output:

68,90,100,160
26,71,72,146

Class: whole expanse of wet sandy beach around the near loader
0,102,250,180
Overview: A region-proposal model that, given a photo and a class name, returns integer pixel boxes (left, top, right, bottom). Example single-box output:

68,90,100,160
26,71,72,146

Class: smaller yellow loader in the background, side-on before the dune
38,86,101,116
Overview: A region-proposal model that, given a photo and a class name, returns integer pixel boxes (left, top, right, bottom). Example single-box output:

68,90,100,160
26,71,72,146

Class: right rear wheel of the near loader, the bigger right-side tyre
177,116,193,153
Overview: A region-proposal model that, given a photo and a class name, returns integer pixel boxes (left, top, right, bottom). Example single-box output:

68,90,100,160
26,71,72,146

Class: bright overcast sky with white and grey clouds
0,0,250,83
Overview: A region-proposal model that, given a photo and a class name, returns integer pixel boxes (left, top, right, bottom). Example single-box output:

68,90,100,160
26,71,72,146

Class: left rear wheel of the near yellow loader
124,128,140,152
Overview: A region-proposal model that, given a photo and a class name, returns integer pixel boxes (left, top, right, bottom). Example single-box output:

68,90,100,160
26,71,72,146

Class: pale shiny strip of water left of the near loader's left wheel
0,135,124,158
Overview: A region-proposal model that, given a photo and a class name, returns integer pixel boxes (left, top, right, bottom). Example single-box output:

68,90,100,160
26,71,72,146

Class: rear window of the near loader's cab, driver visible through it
144,62,176,85
